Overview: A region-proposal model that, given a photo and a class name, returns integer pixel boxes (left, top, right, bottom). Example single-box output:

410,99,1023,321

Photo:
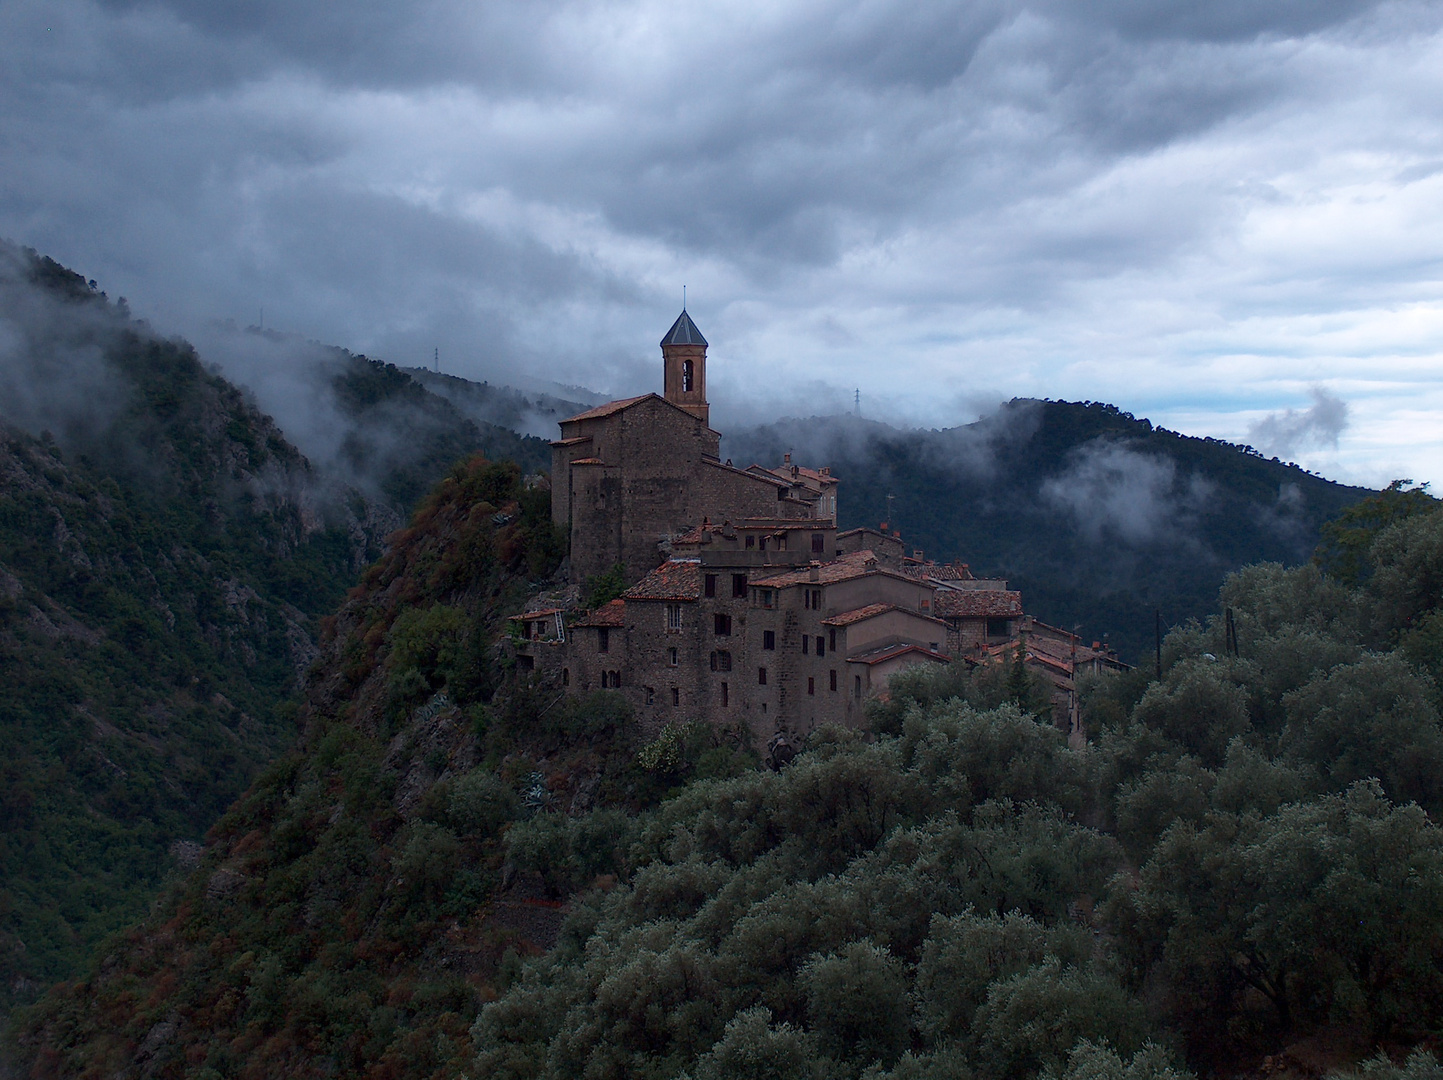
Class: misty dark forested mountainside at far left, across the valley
0,245,395,1012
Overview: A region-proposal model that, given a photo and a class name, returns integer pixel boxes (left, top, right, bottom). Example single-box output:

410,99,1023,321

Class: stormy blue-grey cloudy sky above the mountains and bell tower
0,0,1443,485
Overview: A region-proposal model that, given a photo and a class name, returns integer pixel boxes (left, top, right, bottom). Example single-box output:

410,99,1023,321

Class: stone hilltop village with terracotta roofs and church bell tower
512,310,1123,745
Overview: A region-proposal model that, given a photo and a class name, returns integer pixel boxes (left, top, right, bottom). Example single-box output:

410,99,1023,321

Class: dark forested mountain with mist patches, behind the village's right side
723,399,1369,663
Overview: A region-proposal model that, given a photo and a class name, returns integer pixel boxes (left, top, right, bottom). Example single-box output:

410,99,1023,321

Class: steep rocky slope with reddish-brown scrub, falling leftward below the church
9,459,603,1076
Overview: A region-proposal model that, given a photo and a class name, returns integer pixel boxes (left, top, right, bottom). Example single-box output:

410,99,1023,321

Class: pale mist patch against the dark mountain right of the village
1040,440,1212,547
